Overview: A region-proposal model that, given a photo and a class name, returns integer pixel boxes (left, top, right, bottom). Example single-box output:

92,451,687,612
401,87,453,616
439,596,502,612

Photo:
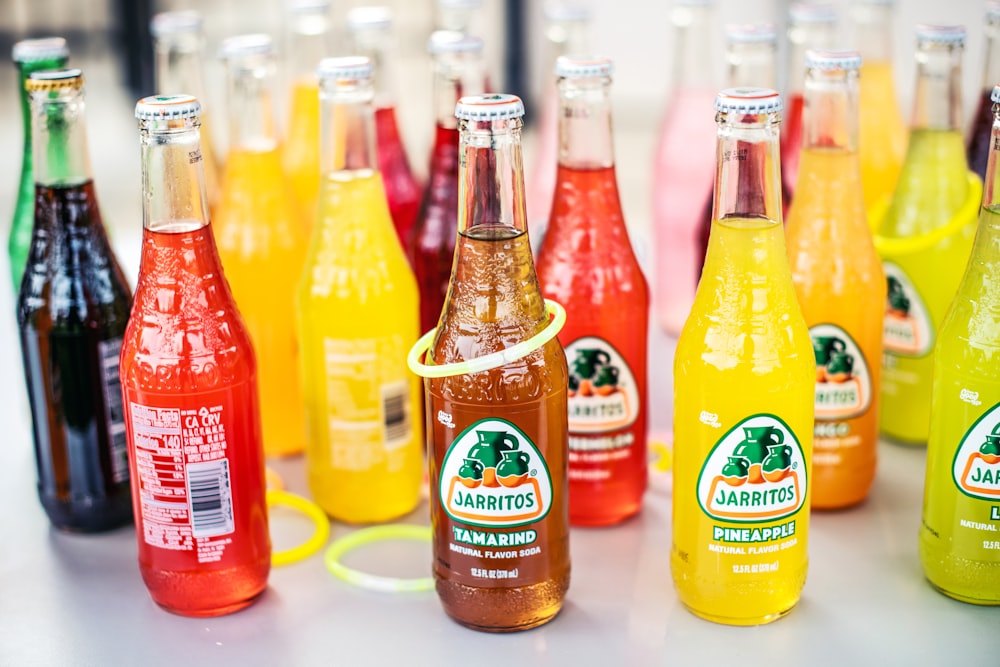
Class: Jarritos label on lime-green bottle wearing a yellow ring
882,262,934,357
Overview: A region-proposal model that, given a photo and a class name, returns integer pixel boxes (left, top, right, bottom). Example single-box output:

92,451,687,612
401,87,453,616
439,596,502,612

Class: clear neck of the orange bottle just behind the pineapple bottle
802,69,858,153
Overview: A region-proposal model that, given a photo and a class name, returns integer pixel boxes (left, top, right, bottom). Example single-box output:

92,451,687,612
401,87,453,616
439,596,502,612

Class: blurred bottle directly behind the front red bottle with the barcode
149,10,221,218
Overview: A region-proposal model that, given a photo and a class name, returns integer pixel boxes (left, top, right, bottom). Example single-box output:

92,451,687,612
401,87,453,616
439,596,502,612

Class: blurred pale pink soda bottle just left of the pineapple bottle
653,0,719,336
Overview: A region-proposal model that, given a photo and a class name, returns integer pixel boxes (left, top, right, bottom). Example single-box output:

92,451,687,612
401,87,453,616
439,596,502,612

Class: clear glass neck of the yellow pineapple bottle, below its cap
712,112,781,222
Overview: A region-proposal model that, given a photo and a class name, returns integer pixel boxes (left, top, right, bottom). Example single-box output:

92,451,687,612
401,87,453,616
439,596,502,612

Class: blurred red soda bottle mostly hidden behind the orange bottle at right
781,2,837,198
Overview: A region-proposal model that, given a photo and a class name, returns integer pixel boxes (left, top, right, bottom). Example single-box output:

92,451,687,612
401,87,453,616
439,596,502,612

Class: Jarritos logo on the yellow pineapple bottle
698,414,808,523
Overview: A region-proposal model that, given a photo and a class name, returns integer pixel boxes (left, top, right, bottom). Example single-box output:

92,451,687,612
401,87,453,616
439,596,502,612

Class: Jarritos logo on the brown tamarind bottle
438,418,552,528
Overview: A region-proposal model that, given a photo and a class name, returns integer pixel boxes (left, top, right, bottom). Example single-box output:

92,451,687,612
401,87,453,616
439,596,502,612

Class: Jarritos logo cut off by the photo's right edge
951,403,1000,501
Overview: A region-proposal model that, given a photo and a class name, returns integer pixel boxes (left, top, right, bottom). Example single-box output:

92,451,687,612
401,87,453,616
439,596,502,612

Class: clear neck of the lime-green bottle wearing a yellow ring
911,43,962,132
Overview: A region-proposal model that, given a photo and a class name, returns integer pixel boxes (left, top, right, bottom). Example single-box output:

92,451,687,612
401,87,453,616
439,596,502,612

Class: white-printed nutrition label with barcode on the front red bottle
129,402,235,563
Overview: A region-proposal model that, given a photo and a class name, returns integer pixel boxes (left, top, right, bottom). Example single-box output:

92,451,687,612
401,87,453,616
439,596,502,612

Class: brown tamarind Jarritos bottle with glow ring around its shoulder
424,95,570,632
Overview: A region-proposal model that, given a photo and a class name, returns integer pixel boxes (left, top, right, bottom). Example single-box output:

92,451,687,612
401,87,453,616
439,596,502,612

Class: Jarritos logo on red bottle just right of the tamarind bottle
566,336,639,433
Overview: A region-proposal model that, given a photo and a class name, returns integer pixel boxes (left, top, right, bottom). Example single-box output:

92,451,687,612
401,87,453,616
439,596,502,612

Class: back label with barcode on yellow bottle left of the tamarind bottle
323,336,413,471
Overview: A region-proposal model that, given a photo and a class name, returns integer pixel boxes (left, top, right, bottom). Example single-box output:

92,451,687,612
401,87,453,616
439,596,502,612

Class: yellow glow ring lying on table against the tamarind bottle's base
323,523,434,593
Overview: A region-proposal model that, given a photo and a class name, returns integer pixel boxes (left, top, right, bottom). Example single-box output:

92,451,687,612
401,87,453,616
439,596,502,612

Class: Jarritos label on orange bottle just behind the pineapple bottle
809,324,872,419
